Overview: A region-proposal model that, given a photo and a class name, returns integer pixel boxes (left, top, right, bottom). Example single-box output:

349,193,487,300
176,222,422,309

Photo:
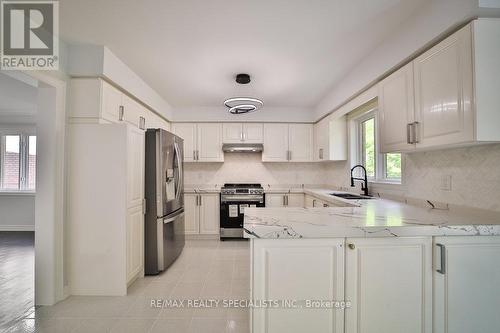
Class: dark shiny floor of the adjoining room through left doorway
0,231,35,332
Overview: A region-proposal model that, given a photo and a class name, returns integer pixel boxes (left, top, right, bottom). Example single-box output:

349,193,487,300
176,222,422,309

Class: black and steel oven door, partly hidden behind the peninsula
220,194,265,238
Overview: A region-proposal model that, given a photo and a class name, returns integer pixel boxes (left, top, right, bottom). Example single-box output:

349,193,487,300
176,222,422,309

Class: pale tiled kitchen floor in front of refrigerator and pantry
1,240,250,333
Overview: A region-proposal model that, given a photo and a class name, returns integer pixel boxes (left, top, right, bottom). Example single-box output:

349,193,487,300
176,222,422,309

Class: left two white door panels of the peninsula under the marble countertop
251,237,434,333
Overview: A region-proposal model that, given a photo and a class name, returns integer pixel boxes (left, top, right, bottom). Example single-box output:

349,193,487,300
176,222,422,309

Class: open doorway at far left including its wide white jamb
0,71,66,331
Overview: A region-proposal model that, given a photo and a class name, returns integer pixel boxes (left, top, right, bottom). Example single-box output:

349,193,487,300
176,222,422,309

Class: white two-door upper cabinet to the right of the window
379,19,500,153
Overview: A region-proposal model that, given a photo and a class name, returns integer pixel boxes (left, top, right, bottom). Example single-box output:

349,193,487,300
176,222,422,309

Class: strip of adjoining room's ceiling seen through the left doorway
0,72,38,116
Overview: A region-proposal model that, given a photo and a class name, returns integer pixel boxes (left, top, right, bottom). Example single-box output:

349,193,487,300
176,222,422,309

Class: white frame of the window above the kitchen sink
351,107,404,185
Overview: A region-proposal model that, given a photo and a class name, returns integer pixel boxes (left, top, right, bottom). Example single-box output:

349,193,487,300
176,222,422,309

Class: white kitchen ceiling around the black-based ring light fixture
60,0,430,108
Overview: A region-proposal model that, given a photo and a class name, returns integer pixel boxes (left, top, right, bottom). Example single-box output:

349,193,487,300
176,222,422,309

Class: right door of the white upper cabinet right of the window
414,25,474,149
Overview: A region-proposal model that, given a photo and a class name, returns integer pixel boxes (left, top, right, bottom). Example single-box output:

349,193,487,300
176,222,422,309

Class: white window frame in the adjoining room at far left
0,126,36,194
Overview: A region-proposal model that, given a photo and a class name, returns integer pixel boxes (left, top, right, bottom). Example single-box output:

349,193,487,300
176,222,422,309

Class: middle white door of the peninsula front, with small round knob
345,237,432,333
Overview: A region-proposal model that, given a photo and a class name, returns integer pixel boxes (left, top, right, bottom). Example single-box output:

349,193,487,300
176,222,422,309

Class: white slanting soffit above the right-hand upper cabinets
314,0,500,119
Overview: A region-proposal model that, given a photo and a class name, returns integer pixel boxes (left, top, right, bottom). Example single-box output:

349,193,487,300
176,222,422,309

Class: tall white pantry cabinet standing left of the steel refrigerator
67,122,144,296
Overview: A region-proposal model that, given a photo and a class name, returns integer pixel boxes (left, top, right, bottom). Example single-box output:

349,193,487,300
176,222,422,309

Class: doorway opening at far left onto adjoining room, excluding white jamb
0,73,38,330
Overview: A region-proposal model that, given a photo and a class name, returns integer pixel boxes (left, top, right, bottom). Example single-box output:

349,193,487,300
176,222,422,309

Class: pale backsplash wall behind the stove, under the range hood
184,153,346,187
